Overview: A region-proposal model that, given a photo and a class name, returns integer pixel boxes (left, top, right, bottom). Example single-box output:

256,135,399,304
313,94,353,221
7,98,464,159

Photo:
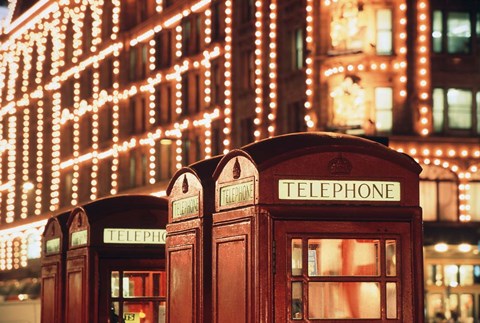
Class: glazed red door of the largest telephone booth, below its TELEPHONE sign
274,221,416,322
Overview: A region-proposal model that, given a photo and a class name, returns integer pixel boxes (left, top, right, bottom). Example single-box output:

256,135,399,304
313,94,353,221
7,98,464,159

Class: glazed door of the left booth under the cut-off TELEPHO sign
99,259,167,323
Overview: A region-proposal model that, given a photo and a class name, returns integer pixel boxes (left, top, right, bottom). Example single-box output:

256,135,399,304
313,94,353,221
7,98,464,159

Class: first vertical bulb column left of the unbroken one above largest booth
202,8,212,158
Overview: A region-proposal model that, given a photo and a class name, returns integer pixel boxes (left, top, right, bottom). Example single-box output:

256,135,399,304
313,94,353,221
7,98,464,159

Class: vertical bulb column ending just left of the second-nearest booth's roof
148,38,160,184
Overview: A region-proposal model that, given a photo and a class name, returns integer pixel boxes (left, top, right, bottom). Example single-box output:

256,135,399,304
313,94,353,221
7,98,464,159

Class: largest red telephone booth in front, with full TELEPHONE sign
212,133,423,323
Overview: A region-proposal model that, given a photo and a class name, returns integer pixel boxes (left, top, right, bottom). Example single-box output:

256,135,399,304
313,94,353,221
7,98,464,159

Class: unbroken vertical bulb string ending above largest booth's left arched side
223,0,233,154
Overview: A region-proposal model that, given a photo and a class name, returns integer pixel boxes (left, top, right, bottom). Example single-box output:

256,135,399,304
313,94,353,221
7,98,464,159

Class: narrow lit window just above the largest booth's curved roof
375,87,393,132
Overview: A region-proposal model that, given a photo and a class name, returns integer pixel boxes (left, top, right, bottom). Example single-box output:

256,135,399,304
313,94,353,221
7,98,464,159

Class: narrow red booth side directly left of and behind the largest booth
166,156,221,323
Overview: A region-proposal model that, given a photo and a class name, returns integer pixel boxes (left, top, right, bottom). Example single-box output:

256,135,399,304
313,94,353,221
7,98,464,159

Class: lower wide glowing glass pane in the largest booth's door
308,282,380,319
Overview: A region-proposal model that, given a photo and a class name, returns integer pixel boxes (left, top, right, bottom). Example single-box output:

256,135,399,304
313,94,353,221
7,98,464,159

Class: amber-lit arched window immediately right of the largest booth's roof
420,165,458,221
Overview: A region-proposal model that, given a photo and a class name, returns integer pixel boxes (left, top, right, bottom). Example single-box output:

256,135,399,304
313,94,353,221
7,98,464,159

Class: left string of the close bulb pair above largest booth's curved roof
253,0,263,141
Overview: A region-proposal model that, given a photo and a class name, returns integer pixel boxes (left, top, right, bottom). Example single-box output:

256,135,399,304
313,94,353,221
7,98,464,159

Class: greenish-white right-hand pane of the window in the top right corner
447,12,472,54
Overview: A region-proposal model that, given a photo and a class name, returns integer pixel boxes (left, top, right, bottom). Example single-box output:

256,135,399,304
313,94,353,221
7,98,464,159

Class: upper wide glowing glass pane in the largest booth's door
308,239,380,276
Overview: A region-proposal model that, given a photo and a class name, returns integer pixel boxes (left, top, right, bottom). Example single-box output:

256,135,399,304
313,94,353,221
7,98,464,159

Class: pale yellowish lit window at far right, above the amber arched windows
433,88,474,133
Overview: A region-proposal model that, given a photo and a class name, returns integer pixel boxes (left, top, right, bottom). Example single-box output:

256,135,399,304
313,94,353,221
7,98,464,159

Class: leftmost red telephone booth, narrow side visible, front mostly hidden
41,212,69,323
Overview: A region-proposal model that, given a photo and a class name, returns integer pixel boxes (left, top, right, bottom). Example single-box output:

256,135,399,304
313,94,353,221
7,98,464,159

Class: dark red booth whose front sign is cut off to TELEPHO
65,196,168,323
